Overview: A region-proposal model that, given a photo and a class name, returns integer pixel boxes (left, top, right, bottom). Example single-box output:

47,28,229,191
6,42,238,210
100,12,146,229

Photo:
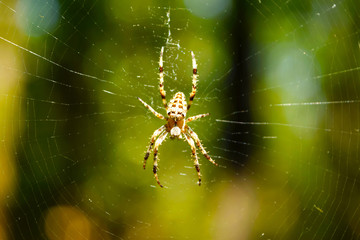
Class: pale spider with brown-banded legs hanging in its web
138,47,218,187
